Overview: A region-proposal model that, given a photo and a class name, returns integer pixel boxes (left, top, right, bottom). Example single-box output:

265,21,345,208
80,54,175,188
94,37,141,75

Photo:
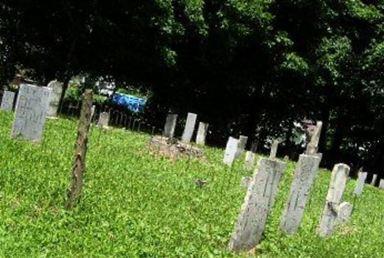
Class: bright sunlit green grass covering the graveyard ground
0,112,384,257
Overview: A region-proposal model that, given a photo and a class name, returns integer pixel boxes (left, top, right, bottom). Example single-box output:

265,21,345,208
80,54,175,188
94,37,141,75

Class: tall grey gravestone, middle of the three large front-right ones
280,154,321,234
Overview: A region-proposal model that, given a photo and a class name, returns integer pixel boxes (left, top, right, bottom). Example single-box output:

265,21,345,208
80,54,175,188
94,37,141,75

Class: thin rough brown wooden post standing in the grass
66,89,93,209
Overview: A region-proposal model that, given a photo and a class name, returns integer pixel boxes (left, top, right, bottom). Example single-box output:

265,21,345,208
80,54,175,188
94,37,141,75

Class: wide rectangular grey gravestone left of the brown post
11,84,51,142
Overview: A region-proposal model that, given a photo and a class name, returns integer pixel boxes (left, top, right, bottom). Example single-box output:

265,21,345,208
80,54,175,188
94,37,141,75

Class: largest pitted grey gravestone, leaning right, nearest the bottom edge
229,158,286,251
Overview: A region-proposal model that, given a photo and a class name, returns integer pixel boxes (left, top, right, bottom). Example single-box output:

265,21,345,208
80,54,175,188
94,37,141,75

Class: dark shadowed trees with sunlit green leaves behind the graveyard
0,0,384,175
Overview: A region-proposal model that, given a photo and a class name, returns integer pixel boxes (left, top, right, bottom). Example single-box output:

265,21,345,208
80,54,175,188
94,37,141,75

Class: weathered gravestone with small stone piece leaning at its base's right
318,164,352,237
